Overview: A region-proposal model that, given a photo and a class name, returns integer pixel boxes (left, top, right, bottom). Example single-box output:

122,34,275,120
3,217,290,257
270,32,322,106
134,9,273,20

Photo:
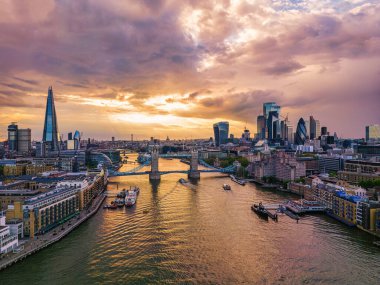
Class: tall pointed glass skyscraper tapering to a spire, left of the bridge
42,86,60,151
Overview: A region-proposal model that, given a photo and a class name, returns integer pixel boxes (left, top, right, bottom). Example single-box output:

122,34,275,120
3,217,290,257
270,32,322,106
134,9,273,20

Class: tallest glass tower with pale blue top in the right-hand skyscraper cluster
263,102,281,140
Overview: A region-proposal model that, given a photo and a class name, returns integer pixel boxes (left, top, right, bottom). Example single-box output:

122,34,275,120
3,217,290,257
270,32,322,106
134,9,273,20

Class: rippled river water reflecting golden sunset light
0,155,380,285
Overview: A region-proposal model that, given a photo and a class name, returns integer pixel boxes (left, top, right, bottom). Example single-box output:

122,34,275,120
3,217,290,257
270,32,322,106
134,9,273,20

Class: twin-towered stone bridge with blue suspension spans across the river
109,149,236,178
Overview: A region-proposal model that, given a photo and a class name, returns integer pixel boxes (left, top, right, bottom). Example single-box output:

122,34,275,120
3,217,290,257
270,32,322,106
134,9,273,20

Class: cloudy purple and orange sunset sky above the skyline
0,0,380,140
